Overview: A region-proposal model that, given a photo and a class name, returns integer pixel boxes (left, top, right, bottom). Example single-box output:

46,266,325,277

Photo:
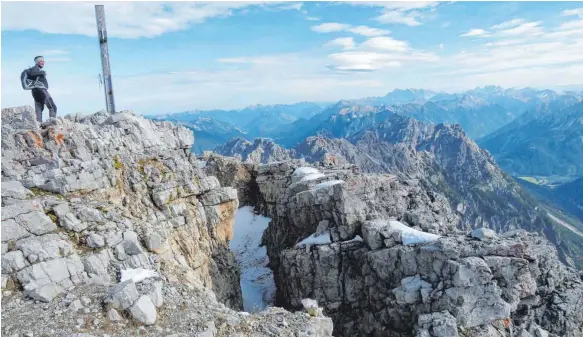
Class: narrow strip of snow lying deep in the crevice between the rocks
229,206,276,313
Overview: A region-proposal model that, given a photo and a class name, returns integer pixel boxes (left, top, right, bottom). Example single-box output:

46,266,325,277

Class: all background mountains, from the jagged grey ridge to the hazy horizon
151,86,583,266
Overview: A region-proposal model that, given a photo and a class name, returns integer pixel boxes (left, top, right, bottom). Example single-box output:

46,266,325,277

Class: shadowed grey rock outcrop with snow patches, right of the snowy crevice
207,161,583,337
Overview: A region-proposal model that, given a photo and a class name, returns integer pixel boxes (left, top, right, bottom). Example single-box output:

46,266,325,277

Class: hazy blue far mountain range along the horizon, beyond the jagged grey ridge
146,86,583,152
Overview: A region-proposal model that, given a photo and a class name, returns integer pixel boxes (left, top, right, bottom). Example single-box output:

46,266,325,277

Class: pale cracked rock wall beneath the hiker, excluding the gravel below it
2,109,241,308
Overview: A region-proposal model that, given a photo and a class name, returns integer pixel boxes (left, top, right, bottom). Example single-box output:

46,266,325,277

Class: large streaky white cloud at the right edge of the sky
450,7,583,85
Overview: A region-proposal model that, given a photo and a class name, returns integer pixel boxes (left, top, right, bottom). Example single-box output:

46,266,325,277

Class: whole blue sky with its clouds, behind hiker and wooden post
2,2,583,115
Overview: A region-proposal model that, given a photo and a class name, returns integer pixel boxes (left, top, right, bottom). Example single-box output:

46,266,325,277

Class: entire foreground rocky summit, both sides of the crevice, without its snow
2,107,583,337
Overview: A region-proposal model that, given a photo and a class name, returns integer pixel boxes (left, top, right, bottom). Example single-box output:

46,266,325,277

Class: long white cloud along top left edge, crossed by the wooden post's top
2,2,301,38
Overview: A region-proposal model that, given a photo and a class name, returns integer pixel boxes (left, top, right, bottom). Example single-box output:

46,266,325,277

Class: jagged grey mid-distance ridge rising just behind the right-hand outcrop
216,112,583,268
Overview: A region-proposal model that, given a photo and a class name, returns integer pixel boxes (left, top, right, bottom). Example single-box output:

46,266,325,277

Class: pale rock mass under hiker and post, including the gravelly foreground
2,107,331,336
